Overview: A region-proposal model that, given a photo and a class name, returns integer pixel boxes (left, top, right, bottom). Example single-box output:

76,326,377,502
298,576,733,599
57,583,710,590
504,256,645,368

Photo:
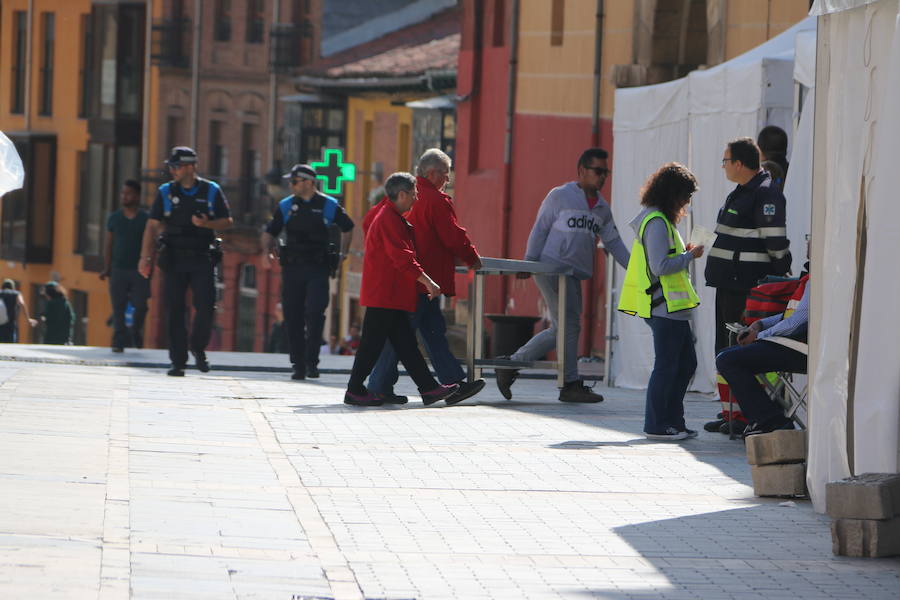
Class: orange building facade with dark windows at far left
0,0,125,343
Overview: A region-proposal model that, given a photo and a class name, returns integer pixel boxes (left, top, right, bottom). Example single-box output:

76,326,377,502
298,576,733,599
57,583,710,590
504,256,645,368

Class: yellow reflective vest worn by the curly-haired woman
619,210,700,319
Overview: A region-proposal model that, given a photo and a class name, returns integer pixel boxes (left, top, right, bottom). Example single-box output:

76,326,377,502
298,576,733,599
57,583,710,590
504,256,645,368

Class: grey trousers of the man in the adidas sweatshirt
510,275,581,383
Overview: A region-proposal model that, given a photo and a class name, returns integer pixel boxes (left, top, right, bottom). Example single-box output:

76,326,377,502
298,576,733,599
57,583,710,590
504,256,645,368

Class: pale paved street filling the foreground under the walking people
0,345,900,600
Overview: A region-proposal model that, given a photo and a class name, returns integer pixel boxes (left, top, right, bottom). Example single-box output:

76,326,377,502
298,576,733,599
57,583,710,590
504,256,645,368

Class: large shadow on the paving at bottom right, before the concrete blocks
558,500,900,600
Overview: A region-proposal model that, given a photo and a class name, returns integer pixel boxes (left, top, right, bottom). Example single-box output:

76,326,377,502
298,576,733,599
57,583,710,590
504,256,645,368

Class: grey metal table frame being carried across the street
456,256,573,388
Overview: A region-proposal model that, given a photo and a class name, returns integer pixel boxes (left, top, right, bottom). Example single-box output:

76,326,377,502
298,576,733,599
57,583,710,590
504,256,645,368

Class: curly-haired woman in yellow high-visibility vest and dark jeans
619,163,703,440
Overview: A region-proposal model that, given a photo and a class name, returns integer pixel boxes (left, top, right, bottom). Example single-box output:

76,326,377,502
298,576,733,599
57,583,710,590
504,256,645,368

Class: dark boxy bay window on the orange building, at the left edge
0,133,56,263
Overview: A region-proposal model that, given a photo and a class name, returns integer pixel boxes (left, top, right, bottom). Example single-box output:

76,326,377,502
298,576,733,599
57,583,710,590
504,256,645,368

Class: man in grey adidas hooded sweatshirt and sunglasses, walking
497,148,630,402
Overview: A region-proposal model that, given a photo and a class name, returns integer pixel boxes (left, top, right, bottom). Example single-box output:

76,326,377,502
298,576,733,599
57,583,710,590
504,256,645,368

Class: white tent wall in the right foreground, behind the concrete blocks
808,0,900,511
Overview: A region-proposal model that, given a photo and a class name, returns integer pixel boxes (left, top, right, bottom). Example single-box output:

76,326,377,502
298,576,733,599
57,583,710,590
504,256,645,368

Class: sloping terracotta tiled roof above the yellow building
300,8,460,79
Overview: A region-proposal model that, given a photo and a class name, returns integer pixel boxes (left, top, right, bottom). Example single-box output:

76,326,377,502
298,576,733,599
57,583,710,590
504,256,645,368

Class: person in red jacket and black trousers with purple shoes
344,173,465,406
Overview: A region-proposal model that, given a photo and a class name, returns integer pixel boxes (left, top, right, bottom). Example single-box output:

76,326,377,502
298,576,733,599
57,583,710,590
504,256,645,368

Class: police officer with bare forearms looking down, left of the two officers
138,146,233,377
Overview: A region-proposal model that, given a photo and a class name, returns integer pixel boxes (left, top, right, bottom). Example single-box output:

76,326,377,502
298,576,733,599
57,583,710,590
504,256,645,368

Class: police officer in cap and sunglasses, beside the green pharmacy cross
261,165,353,379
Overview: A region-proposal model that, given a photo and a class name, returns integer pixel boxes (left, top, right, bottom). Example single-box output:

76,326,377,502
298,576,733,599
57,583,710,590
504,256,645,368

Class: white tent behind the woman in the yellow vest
609,18,816,392
